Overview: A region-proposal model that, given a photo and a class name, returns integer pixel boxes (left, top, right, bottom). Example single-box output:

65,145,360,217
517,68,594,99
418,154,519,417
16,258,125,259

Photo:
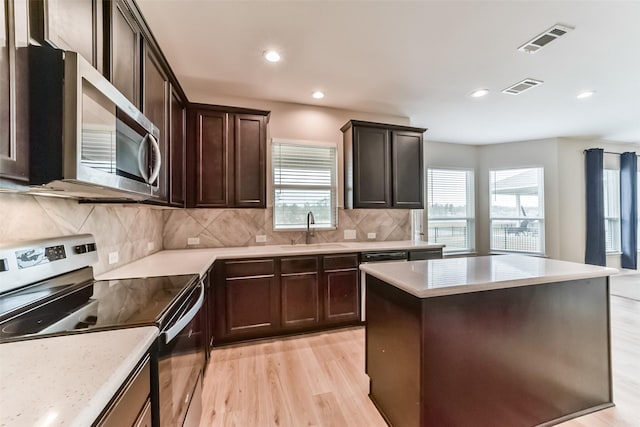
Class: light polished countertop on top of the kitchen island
360,255,618,298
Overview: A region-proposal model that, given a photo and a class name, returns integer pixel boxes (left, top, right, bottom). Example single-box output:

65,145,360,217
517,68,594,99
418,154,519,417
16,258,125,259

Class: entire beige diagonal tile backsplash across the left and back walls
0,193,411,274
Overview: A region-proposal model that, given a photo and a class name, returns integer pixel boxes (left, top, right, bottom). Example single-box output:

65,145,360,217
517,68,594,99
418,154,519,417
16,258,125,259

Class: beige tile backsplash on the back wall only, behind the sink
163,209,411,249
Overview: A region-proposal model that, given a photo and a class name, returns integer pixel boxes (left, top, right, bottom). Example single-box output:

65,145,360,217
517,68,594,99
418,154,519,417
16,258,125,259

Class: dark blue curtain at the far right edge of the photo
620,152,638,270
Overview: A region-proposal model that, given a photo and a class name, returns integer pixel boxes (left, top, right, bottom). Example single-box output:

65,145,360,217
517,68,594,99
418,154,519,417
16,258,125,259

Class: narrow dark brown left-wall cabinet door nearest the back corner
169,85,186,207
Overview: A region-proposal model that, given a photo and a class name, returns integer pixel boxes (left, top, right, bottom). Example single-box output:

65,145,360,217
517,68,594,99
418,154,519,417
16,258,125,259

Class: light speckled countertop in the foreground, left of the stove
0,326,158,427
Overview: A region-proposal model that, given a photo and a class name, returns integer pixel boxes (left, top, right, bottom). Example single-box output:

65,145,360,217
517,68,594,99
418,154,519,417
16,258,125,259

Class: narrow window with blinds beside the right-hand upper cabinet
427,169,475,252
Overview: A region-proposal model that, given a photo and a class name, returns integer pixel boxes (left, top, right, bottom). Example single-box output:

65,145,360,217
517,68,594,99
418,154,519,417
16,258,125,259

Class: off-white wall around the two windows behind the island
425,138,640,267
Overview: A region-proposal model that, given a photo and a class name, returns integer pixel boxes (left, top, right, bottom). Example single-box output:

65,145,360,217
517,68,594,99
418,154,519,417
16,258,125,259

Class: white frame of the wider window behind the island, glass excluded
488,165,546,257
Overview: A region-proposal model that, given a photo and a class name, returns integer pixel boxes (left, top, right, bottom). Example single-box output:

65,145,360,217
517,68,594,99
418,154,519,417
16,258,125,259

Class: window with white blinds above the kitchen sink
271,142,338,230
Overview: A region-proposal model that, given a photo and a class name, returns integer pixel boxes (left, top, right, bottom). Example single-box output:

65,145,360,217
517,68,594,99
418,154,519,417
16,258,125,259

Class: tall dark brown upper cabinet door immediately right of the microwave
142,46,170,201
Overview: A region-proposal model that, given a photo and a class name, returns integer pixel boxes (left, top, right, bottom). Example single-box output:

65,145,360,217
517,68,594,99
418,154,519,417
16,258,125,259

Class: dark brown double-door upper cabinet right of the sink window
341,120,426,209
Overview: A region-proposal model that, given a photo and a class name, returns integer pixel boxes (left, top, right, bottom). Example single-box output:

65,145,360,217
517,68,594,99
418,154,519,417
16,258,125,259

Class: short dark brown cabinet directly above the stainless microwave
29,0,104,72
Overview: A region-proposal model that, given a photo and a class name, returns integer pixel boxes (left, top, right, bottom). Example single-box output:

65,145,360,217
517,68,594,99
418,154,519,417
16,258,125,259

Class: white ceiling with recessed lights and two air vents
138,0,640,144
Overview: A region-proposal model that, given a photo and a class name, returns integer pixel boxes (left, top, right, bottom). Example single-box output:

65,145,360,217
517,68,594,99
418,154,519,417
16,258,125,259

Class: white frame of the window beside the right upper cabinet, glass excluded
425,166,476,254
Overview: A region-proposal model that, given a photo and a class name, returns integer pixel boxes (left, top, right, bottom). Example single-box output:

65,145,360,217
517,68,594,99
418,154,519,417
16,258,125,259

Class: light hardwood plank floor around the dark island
200,296,640,427
